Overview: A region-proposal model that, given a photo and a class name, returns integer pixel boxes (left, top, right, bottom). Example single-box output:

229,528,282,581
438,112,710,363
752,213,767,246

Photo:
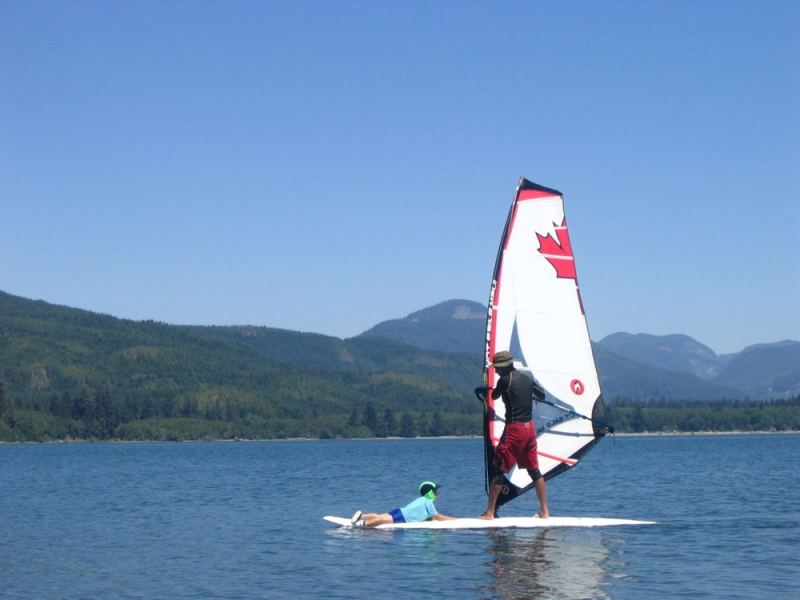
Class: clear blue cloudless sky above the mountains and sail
0,0,800,353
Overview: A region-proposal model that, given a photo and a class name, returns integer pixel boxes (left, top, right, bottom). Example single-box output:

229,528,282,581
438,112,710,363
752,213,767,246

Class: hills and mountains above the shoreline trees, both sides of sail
0,292,800,404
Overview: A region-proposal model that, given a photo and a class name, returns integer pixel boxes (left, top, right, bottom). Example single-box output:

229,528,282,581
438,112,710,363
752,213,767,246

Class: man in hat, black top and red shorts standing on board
475,350,550,519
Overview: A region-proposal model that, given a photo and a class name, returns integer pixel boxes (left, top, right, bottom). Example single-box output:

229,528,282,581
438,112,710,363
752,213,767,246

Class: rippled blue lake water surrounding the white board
0,435,800,600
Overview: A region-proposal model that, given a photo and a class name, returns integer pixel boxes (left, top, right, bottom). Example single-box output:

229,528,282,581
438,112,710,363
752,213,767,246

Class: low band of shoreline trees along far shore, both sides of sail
0,380,800,441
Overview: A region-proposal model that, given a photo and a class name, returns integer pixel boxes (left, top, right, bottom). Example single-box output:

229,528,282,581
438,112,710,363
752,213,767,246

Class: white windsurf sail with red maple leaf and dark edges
484,177,609,506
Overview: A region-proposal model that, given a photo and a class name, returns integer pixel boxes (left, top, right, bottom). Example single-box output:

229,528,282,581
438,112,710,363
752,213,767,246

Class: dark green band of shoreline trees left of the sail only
0,380,481,441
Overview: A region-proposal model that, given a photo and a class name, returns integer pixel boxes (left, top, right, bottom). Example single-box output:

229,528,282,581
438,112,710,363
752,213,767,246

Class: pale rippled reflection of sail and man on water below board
480,528,618,600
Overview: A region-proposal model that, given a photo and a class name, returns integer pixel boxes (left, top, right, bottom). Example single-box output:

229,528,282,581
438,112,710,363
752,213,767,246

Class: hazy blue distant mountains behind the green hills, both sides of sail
362,300,800,400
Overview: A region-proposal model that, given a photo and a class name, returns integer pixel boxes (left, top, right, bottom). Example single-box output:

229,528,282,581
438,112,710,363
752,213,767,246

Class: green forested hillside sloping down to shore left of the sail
0,292,480,439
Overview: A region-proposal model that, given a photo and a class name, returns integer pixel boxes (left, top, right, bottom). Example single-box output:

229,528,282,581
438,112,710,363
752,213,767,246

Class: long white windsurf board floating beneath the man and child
323,517,655,529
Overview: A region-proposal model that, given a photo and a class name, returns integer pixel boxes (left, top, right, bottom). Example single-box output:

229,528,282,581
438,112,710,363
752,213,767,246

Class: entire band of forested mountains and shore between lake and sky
0,292,800,440
